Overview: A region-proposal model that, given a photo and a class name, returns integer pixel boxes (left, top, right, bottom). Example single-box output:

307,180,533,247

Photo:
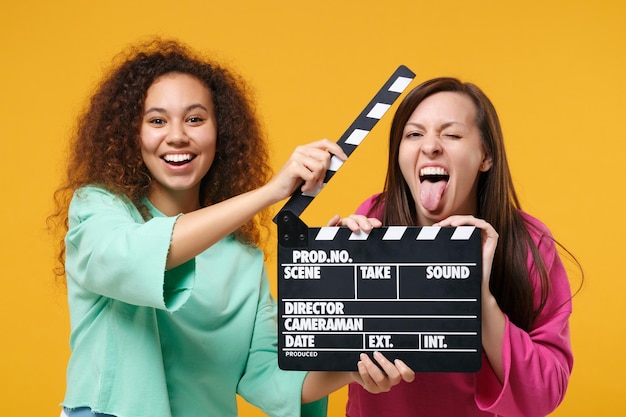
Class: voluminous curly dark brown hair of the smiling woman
48,38,271,276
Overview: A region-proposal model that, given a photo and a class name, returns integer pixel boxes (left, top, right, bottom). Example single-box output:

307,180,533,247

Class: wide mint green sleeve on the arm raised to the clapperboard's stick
65,187,195,311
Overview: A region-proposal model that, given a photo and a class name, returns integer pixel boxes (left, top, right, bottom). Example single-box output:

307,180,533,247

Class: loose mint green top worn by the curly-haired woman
63,187,326,417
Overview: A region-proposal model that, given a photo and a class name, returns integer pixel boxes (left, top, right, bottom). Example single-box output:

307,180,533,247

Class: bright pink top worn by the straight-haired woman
346,197,573,417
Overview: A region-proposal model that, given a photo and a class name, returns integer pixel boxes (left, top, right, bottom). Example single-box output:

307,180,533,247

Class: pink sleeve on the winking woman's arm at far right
475,219,573,417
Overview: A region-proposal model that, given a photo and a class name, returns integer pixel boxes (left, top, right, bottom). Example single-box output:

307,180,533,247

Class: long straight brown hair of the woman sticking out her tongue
372,77,550,330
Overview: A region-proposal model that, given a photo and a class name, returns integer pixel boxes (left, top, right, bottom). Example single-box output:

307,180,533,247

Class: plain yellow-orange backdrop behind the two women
0,0,626,416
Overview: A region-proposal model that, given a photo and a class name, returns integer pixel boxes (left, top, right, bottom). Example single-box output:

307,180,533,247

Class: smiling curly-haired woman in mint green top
50,40,413,417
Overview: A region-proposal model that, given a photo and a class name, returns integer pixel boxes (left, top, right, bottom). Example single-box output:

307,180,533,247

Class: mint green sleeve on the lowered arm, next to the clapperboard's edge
237,268,328,417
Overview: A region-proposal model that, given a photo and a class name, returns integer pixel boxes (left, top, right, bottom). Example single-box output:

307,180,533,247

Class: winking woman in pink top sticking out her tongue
330,77,576,417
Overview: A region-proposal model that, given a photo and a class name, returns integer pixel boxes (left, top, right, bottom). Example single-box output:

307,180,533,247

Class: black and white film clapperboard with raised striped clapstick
274,66,482,372
